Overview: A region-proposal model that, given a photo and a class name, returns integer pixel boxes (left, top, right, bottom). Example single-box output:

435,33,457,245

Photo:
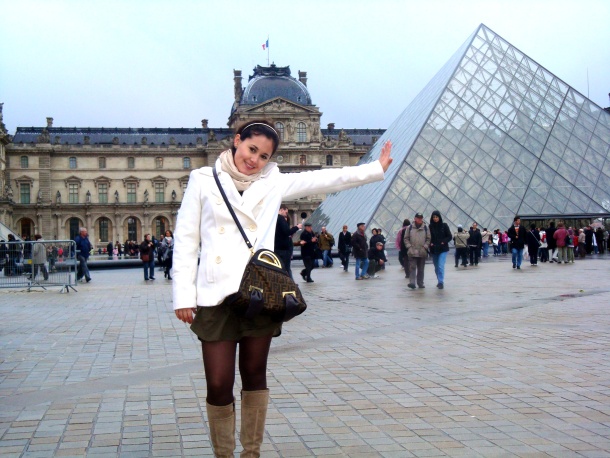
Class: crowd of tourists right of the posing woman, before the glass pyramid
276,206,608,289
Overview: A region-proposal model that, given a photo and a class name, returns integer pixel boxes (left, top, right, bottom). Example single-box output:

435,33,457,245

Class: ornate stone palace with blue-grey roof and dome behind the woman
0,65,384,248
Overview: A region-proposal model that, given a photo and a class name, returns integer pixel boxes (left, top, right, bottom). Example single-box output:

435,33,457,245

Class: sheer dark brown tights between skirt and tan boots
201,336,272,406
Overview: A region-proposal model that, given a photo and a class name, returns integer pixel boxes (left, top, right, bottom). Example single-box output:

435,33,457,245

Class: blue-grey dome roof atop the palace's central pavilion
240,64,312,105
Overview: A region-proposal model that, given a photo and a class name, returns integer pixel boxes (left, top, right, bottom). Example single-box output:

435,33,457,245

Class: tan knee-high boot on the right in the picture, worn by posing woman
239,390,269,458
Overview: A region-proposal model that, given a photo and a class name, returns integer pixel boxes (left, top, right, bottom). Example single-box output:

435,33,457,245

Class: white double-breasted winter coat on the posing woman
172,156,383,309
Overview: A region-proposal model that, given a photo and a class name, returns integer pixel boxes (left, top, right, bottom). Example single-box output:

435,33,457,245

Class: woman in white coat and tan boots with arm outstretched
173,120,392,456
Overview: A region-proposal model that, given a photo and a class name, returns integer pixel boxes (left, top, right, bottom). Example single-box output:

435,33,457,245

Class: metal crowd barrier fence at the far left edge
0,240,78,293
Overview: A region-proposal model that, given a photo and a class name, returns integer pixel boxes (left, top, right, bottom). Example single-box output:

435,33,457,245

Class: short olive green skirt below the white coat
191,302,282,342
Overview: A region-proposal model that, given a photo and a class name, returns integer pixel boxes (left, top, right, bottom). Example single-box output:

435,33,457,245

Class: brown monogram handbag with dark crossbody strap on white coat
213,168,307,322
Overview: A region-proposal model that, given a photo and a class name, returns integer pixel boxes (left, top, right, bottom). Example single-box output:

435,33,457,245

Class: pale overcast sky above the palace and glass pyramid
0,0,610,134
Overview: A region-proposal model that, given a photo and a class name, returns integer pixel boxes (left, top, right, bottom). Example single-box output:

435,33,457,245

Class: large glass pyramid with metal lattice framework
310,24,610,240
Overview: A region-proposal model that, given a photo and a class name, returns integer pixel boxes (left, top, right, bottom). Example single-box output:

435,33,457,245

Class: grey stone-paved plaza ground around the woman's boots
0,256,610,457
